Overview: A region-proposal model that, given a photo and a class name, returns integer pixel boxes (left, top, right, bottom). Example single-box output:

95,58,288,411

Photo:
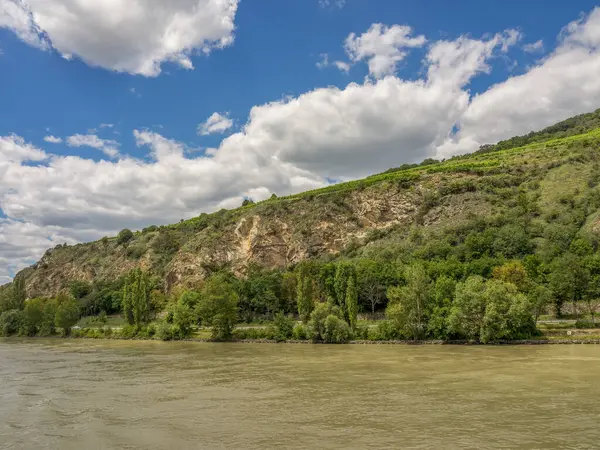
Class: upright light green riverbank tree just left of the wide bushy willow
386,265,431,339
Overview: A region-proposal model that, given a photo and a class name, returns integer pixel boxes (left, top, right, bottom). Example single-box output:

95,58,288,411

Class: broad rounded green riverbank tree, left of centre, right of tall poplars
196,274,239,340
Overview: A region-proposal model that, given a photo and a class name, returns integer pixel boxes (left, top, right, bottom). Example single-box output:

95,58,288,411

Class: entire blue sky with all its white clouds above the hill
0,0,600,284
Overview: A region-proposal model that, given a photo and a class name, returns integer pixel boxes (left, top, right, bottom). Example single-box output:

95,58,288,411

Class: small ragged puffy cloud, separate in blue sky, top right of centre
345,23,427,78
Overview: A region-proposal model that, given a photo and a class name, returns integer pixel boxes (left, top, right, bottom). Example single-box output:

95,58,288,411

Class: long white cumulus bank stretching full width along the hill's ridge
0,9,600,277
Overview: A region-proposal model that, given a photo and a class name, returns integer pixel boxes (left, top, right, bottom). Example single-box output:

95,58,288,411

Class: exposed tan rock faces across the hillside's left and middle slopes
21,185,420,296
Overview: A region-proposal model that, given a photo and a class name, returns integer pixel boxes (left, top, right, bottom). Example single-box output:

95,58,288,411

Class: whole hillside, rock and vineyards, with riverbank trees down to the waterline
0,110,600,344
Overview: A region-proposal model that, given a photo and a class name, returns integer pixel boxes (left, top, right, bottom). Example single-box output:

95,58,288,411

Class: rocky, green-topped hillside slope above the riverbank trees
5,110,600,304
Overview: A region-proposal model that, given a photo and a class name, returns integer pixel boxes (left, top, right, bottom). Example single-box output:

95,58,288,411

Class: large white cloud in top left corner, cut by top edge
0,0,238,76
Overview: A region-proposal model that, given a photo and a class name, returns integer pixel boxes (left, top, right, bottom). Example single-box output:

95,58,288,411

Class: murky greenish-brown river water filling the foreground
0,339,600,450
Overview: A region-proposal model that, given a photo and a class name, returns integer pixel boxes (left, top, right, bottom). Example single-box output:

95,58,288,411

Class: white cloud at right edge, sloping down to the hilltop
439,8,600,156
